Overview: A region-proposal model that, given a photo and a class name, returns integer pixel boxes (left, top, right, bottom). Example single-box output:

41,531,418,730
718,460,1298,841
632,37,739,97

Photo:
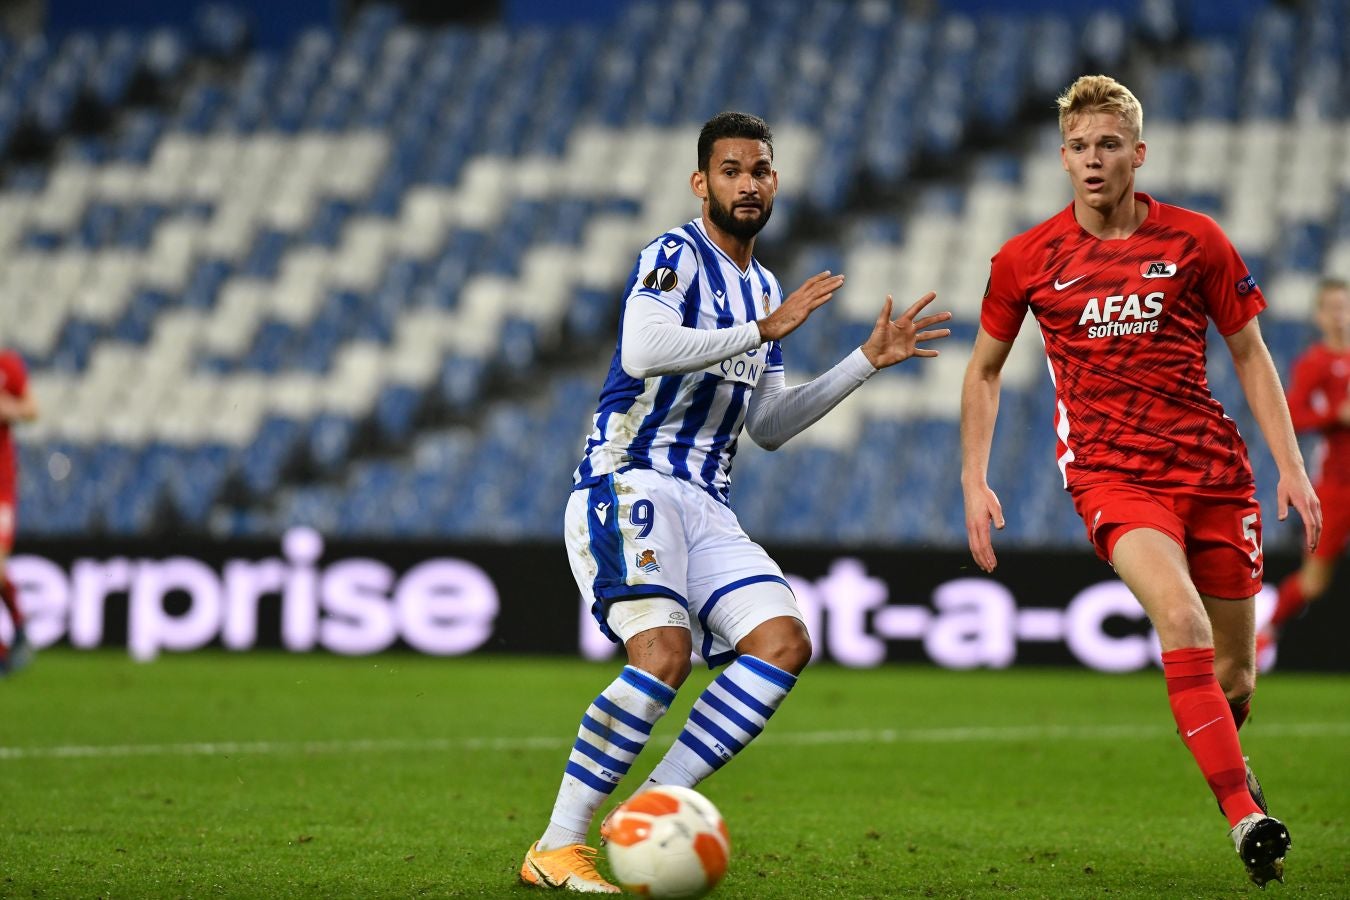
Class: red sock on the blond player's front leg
1162,646,1261,826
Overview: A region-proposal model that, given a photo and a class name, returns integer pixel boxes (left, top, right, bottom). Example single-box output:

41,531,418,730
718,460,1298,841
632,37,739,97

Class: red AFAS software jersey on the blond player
980,193,1265,488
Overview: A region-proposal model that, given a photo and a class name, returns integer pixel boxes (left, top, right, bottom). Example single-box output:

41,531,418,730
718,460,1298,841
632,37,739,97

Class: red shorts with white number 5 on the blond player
1073,482,1264,600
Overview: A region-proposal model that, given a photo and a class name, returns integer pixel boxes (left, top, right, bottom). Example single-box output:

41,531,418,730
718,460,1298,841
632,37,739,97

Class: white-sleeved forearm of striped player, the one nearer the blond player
745,349,876,449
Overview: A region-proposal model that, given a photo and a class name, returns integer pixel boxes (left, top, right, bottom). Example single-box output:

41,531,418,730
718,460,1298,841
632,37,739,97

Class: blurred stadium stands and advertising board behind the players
0,0,1350,669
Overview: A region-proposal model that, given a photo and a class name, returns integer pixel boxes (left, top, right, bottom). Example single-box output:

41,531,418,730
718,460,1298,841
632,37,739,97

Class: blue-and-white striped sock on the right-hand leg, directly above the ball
648,656,797,788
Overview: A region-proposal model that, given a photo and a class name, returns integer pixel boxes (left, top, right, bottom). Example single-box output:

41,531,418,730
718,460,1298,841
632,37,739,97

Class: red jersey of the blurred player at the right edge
1289,344,1350,487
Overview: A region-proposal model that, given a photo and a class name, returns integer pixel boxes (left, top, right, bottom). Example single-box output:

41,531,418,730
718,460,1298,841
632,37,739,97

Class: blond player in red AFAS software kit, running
961,76,1322,885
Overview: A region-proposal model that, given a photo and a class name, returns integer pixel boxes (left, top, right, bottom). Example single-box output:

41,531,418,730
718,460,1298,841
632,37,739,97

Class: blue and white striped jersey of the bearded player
574,219,783,503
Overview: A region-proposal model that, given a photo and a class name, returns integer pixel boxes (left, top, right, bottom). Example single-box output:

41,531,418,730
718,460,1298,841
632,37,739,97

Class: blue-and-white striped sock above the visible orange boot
539,665,675,850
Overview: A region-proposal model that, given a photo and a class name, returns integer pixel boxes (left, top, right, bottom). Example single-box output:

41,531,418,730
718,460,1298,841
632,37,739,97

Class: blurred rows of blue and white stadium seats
0,0,1350,546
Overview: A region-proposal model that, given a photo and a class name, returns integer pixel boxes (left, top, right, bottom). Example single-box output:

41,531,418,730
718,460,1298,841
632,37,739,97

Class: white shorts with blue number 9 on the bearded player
564,468,802,668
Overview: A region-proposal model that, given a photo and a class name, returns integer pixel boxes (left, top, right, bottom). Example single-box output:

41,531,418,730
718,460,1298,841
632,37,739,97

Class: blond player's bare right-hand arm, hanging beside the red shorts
1224,318,1322,552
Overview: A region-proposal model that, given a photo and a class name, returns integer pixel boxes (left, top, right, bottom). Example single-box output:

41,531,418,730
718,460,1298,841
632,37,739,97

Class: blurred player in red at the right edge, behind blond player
1257,278,1350,656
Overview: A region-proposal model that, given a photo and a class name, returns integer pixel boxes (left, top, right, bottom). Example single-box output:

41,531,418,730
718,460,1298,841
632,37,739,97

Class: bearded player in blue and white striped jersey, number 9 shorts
520,112,950,893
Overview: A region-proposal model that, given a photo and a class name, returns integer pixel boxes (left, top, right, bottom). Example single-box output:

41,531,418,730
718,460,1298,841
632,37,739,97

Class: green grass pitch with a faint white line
0,650,1350,900
